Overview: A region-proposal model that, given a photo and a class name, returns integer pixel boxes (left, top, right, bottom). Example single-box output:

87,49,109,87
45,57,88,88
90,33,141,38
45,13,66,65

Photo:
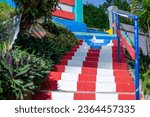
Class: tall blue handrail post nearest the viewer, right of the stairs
134,16,140,100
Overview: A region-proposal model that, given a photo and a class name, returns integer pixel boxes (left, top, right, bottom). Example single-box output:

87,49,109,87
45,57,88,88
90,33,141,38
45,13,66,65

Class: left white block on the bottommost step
52,92,74,100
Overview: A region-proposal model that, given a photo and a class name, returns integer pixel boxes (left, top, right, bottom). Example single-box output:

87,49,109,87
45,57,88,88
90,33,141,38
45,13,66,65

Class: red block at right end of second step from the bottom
116,83,135,92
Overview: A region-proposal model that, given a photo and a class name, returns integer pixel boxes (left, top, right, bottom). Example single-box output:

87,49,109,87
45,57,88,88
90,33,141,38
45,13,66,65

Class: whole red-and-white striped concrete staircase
33,41,135,100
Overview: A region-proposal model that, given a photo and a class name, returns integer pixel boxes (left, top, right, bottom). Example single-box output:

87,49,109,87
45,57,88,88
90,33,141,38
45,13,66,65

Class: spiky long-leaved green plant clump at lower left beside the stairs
0,43,52,99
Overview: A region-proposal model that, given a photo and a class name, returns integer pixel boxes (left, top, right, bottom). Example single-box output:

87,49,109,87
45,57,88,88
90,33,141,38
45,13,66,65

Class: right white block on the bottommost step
96,93,118,100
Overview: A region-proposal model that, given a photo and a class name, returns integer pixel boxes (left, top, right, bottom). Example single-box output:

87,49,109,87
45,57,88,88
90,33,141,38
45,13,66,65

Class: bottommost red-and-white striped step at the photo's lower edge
32,91,135,100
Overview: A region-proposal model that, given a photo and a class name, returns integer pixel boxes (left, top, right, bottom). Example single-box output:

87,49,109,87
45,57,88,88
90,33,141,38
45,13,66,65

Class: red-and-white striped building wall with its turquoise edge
53,0,83,22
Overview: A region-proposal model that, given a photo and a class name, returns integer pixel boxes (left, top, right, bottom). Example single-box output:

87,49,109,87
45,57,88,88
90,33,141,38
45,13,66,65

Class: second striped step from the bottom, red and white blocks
42,80,135,93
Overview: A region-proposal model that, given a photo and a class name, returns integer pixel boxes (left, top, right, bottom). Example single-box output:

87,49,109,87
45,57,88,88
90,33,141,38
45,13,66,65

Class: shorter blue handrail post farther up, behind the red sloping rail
116,13,121,62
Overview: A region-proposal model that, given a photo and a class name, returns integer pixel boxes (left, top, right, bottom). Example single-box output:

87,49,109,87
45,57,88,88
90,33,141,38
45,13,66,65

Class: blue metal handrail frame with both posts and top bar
112,10,140,100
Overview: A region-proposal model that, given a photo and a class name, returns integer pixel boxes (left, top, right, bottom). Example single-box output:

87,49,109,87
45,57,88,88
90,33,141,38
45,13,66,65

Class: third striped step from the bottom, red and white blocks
45,72,133,83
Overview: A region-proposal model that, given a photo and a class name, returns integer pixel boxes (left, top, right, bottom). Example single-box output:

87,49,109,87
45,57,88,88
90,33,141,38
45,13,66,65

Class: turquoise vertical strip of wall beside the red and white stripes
74,0,83,23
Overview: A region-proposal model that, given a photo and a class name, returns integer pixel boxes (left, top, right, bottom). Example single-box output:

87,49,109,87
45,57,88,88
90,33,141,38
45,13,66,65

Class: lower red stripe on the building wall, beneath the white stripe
52,10,75,20
